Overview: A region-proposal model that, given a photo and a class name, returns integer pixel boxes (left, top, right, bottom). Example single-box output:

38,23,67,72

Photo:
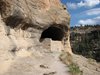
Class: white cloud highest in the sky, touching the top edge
67,0,100,9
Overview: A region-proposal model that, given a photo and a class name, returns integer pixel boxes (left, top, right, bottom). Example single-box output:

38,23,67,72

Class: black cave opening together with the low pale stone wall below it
40,26,64,52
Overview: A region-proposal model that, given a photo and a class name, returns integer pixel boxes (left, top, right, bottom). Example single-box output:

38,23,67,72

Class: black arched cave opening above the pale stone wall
40,27,64,42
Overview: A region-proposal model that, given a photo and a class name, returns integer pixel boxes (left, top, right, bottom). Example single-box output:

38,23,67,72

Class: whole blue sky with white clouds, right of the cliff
61,0,100,26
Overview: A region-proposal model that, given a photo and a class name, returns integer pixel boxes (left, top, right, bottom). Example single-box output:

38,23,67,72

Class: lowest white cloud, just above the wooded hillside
78,16,100,25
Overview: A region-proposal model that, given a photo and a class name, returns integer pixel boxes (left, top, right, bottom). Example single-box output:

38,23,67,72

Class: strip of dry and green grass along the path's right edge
60,52,83,75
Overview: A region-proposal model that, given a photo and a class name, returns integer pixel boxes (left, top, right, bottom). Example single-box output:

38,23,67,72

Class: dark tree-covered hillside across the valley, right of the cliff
70,25,100,62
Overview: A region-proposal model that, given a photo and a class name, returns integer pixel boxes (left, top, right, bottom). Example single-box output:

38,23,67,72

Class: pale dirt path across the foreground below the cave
3,53,69,75
